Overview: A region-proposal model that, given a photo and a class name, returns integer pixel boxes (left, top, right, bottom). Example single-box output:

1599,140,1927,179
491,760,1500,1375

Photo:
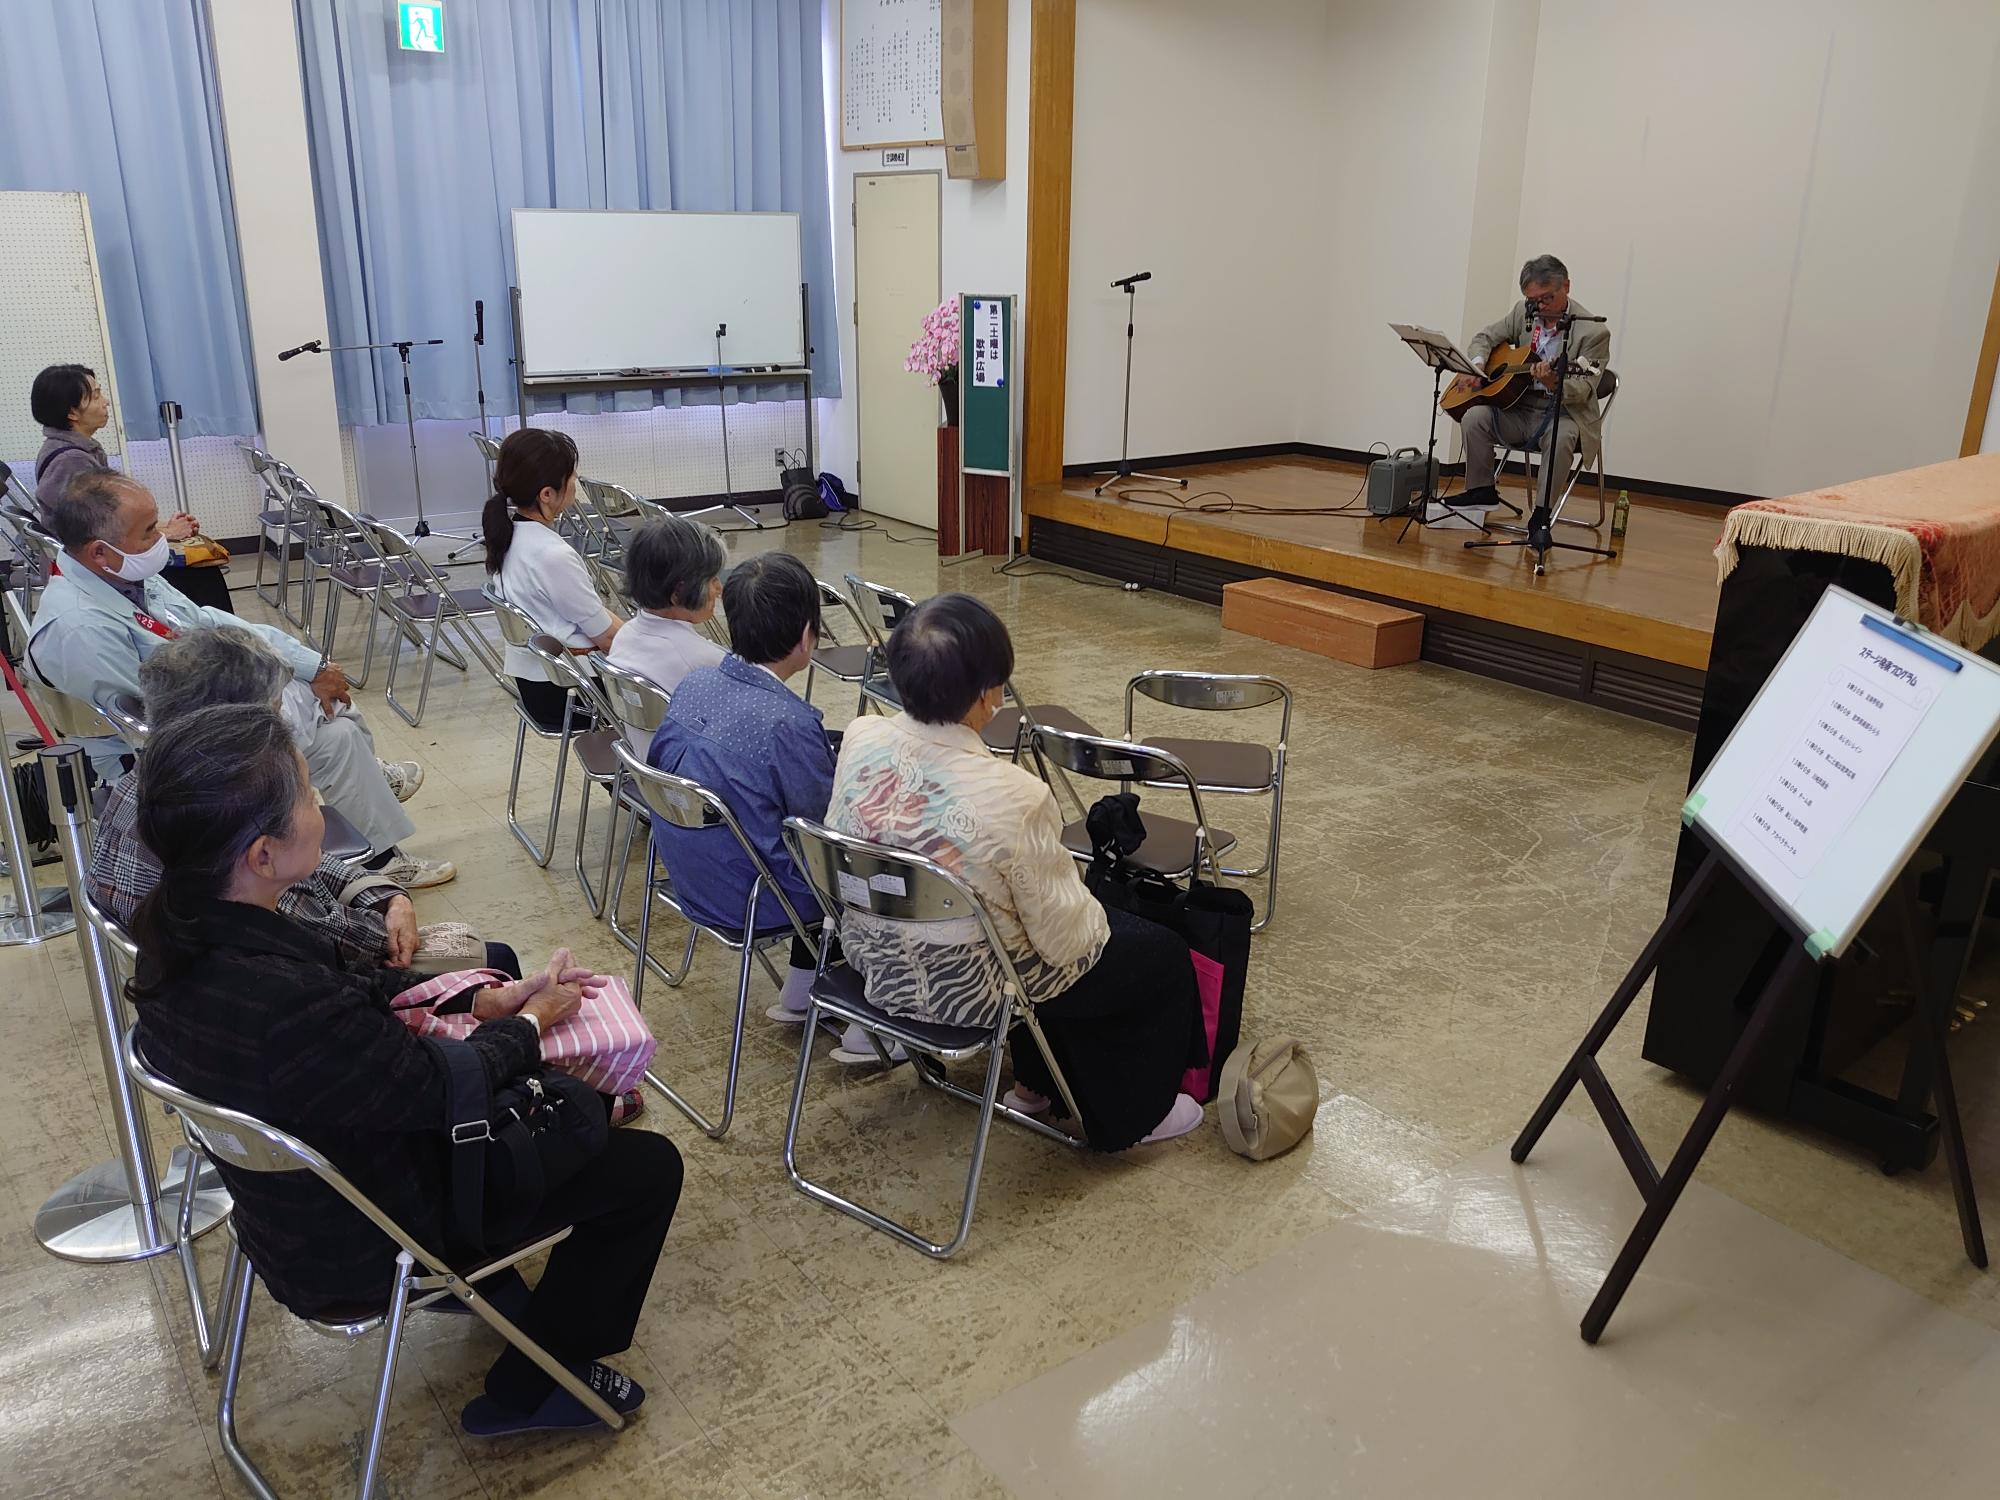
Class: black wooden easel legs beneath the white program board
1510,824,1986,1344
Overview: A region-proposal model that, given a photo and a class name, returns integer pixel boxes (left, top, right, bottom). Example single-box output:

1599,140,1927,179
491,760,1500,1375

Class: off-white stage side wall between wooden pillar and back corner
1064,0,1326,462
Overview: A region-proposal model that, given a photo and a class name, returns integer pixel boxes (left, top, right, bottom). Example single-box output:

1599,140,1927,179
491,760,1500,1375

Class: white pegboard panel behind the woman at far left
0,192,124,468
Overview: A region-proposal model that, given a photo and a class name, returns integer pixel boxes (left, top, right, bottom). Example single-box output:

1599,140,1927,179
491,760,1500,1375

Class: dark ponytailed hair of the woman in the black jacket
126,704,306,1002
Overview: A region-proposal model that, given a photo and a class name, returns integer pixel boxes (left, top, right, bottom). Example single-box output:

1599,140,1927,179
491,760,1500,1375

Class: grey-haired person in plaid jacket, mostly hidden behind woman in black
84,626,520,978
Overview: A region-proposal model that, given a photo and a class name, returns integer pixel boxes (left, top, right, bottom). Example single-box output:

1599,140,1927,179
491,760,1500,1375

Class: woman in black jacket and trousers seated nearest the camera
128,704,682,1436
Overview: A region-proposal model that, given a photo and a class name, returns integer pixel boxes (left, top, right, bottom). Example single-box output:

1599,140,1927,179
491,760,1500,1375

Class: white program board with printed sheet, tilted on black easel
1682,588,2000,956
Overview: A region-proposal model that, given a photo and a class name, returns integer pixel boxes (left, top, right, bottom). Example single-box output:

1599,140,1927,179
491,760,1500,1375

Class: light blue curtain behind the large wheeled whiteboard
296,0,840,424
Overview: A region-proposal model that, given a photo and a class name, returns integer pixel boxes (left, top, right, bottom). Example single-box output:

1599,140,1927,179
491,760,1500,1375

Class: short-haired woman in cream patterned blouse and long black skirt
826,594,1206,1150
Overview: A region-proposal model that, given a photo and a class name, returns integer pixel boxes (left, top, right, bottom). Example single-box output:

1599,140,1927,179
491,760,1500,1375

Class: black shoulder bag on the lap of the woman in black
424,1036,610,1254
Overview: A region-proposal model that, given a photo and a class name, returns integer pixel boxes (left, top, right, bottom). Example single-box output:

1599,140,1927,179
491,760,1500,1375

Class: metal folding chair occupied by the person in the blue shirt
616,736,812,1140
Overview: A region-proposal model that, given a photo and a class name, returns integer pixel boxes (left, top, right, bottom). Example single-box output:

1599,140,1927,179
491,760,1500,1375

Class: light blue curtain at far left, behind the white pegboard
0,0,258,438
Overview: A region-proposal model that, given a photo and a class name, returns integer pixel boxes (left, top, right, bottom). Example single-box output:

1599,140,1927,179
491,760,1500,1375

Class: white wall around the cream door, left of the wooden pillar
820,0,1034,494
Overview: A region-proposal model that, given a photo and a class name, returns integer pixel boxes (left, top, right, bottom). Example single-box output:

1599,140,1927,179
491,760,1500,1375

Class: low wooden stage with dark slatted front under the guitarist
1026,456,1724,728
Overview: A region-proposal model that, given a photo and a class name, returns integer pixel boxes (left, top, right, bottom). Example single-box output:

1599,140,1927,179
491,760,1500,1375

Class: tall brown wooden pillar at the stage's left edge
1022,0,1076,484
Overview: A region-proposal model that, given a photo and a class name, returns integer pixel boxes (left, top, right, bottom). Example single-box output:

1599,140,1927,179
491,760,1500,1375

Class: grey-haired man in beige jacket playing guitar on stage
1450,256,1612,510
